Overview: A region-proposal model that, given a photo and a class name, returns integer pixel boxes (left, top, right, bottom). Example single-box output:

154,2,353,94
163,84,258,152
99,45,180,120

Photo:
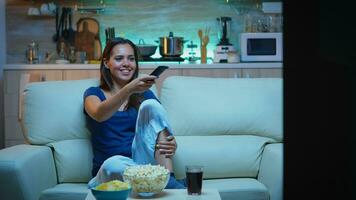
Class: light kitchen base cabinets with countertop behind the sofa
4,63,282,147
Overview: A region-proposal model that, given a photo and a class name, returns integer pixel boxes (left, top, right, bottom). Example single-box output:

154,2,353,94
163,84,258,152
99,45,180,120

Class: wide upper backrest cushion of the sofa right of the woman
160,76,283,141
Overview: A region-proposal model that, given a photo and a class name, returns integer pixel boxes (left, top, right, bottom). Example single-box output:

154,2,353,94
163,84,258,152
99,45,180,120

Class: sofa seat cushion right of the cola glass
203,178,269,200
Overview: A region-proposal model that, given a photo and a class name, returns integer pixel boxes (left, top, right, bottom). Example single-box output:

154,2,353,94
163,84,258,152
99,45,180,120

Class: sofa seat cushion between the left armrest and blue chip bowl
40,183,89,200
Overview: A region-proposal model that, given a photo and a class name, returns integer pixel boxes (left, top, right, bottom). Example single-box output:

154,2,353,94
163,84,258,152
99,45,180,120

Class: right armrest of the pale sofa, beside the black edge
257,143,283,200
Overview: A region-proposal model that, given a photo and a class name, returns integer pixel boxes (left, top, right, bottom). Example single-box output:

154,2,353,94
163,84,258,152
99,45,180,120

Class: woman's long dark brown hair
100,37,143,109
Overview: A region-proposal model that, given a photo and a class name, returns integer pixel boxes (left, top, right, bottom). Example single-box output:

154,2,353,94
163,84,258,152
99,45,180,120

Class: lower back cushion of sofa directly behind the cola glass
173,135,274,179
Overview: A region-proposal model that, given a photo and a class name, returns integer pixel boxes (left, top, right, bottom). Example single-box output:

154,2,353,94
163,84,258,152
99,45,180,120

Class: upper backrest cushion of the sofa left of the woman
23,79,99,144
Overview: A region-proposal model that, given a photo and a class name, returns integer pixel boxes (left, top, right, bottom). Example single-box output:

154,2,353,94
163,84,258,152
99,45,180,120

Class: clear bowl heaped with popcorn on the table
123,164,170,197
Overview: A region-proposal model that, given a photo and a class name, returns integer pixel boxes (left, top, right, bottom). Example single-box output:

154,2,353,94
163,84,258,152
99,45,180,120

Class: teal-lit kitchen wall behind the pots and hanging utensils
6,0,280,64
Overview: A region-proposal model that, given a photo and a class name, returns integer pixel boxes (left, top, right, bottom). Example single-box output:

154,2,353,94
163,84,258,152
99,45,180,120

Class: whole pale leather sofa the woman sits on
0,76,283,200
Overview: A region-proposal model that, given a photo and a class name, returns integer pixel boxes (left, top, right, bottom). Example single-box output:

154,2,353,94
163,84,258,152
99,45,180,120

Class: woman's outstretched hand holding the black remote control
126,75,157,94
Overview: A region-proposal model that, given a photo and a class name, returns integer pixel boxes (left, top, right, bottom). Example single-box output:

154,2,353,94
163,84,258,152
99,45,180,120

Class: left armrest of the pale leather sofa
0,144,57,200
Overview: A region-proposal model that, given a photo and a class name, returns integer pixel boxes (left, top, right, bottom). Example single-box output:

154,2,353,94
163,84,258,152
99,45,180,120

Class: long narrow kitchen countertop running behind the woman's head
4,62,283,70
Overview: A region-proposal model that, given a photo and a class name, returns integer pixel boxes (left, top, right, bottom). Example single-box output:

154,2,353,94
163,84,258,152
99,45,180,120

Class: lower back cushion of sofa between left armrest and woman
48,139,93,183
